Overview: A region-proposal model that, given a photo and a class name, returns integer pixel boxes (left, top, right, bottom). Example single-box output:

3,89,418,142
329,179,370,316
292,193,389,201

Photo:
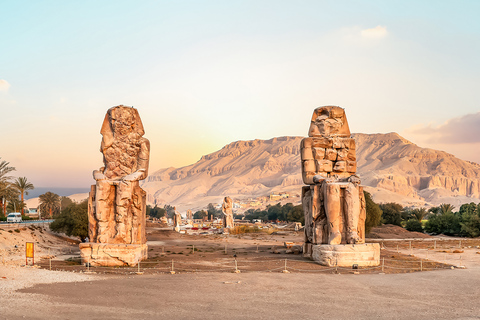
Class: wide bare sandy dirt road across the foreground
0,268,480,319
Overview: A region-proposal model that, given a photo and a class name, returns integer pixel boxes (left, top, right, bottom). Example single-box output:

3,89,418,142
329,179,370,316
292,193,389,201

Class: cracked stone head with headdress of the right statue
308,106,350,137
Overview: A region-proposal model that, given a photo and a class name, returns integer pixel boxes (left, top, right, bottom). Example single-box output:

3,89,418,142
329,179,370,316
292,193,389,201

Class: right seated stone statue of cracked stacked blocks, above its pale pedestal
301,106,380,262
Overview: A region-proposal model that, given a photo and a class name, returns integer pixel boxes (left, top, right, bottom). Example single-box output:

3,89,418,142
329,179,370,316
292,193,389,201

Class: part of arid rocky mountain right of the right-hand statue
354,133,480,208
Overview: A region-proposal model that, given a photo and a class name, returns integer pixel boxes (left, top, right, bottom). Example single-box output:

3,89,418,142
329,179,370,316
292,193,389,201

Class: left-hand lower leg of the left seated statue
96,180,113,243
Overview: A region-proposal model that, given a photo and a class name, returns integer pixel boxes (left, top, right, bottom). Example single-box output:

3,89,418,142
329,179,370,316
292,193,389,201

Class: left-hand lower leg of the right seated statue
322,182,342,244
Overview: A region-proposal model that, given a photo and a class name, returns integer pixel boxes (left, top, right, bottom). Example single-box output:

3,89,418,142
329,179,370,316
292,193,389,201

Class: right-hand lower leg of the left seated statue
115,182,133,243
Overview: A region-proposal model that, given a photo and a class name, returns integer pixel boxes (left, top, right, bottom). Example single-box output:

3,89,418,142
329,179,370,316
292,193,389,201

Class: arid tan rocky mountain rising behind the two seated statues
142,133,480,211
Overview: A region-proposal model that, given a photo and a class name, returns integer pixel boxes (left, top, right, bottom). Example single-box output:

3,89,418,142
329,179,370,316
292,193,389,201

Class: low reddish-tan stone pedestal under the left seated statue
80,242,148,267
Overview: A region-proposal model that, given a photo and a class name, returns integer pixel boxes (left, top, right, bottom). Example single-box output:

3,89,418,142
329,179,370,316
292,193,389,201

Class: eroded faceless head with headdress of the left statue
100,105,145,152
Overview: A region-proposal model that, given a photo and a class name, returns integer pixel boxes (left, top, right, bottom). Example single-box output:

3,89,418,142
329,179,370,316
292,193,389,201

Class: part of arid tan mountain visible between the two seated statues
142,137,303,211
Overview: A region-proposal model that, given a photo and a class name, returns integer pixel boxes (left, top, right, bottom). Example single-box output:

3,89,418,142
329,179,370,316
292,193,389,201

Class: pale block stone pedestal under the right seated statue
311,243,380,268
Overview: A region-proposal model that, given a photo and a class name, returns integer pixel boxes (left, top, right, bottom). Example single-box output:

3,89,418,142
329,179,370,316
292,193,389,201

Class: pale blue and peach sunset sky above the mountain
0,0,480,187
